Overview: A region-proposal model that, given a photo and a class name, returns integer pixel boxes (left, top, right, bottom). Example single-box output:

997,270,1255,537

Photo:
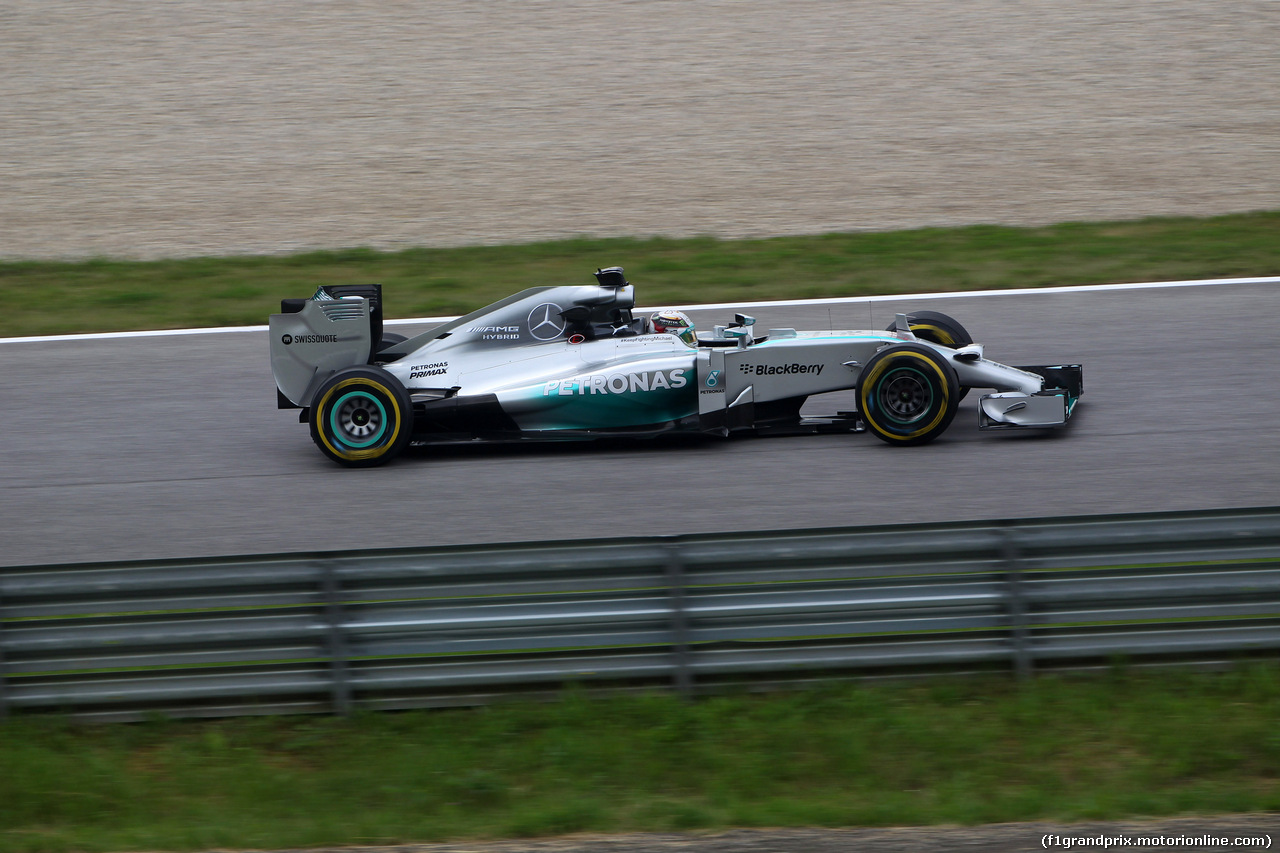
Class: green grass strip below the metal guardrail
0,666,1280,852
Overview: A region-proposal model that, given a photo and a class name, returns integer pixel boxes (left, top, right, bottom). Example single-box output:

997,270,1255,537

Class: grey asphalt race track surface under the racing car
0,280,1280,566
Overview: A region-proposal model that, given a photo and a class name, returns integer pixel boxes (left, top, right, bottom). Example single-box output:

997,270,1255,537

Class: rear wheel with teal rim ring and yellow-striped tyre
310,366,413,467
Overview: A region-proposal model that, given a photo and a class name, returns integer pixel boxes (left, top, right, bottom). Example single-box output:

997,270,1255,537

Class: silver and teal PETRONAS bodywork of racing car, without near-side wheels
270,270,1082,441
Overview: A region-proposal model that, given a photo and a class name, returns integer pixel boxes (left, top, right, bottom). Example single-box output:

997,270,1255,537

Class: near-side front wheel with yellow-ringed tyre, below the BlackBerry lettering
858,343,960,444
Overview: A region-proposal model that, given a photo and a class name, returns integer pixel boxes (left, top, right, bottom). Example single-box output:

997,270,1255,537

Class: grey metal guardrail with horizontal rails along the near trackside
0,507,1280,720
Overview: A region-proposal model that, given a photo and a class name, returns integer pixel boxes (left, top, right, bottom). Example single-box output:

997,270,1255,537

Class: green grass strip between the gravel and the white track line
0,211,1280,337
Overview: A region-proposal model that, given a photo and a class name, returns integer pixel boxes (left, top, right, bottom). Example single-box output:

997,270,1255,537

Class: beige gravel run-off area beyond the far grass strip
0,0,1280,259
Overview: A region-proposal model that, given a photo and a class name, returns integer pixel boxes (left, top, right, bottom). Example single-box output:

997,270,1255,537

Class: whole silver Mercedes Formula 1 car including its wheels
270,266,1083,466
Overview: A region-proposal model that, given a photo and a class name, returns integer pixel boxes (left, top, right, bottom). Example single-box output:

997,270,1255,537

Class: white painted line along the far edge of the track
0,275,1280,343
